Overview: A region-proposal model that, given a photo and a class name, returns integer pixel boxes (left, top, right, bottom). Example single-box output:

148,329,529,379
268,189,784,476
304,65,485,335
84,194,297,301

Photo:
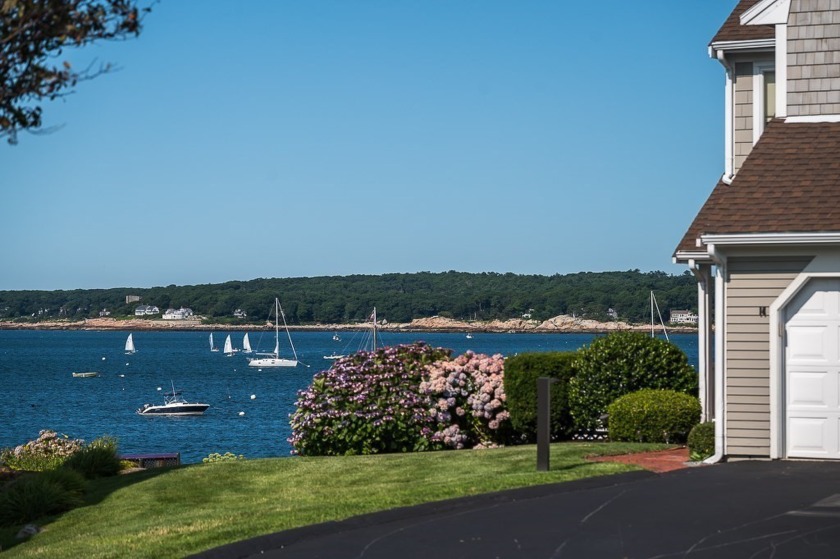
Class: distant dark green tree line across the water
0,270,697,325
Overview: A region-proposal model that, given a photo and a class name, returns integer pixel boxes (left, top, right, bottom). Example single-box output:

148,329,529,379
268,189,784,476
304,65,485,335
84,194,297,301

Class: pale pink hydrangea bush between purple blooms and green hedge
420,351,510,449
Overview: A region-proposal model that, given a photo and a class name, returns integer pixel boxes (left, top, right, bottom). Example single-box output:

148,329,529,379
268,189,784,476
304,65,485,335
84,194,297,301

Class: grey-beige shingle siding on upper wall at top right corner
787,0,840,116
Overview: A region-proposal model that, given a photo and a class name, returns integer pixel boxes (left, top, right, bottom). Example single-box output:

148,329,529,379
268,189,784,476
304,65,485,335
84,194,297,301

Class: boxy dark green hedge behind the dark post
504,351,577,442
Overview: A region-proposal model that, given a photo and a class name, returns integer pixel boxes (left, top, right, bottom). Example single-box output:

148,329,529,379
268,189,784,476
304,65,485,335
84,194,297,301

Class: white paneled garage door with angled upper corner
785,279,840,459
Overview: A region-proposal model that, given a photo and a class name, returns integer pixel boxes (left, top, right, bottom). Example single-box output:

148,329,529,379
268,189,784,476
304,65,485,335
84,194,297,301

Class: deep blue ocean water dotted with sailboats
0,330,697,463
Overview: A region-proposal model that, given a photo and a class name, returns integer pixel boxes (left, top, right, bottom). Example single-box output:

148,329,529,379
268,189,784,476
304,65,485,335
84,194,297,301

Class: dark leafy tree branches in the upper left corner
0,0,150,144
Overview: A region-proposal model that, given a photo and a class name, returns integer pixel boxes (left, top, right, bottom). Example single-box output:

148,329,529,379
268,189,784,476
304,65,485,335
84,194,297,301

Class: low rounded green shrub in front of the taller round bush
607,389,701,443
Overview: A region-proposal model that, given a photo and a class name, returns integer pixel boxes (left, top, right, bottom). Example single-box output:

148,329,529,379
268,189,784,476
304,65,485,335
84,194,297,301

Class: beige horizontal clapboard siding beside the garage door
725,258,808,457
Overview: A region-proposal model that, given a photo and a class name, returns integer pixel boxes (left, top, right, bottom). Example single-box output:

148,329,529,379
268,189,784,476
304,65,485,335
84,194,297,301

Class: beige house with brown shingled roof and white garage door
674,0,840,460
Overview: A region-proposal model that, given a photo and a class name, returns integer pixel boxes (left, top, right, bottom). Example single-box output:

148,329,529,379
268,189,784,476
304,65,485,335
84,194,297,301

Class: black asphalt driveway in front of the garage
194,462,840,559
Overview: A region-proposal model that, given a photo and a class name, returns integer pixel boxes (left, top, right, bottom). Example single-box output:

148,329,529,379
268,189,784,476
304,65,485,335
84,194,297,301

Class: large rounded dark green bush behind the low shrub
569,332,697,431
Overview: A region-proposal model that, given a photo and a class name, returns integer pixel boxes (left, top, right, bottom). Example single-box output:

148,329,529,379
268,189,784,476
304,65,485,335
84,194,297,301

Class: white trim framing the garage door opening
770,250,840,459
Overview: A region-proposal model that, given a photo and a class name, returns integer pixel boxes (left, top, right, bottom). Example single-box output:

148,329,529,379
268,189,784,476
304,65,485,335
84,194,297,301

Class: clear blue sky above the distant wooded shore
0,0,736,290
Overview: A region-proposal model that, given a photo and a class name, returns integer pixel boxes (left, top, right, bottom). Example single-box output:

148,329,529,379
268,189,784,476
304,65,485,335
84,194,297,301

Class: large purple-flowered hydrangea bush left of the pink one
289,342,450,456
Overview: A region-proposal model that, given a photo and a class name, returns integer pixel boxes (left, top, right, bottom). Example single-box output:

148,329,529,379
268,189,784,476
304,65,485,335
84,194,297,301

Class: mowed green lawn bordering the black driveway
2,443,667,559
